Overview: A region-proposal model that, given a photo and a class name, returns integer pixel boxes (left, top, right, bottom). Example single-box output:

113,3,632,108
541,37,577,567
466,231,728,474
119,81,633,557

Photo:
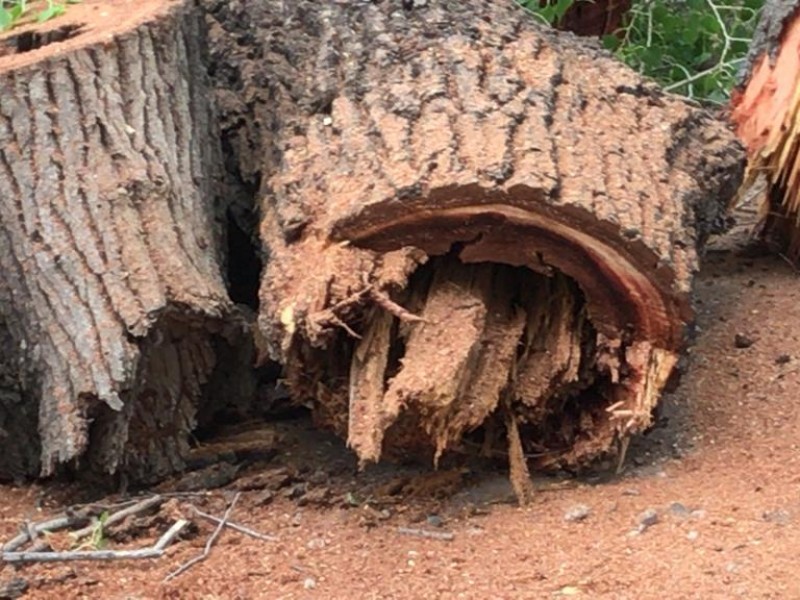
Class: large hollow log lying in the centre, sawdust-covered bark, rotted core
206,0,743,480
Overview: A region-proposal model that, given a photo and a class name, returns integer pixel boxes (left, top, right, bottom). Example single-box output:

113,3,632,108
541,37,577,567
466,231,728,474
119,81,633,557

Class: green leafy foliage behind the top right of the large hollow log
519,0,764,103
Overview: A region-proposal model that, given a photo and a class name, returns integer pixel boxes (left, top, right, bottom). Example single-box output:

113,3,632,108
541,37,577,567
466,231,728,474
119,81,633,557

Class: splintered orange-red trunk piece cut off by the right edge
731,0,800,263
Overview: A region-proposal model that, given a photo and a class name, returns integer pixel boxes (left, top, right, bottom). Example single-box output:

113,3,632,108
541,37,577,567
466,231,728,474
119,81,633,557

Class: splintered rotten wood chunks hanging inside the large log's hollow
348,256,594,499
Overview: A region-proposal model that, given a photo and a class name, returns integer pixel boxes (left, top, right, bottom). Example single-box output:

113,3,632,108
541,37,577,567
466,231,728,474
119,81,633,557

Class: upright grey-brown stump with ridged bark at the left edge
0,1,247,480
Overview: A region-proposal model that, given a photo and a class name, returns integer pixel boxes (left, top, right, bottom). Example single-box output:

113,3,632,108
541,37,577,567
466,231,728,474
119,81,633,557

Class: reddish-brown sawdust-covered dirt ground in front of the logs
0,225,800,600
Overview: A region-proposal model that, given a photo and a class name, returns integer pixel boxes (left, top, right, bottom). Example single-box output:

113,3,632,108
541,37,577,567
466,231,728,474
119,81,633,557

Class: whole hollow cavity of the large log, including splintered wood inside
289,251,650,482
